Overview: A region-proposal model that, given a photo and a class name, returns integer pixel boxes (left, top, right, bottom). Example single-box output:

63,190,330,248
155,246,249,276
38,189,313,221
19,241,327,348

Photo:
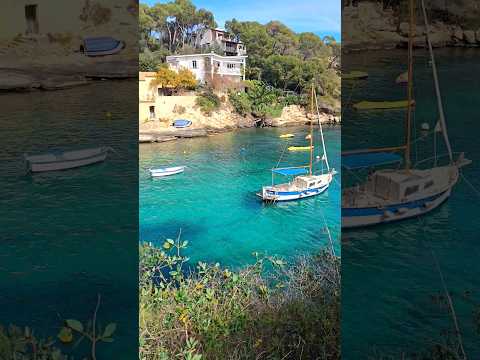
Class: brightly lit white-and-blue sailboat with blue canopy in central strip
257,85,336,202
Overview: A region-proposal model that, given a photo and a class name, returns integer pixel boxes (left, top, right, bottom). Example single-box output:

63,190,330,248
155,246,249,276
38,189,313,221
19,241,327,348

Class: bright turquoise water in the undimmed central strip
139,128,340,267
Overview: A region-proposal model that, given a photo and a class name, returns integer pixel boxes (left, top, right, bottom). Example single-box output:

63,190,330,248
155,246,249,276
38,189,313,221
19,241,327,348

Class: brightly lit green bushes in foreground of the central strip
139,239,340,360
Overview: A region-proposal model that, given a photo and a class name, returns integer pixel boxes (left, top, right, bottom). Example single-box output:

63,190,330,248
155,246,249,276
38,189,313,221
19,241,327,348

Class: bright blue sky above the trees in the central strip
140,0,341,41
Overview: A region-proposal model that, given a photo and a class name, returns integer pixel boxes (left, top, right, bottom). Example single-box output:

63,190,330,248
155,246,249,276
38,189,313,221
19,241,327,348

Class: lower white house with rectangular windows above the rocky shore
166,53,247,88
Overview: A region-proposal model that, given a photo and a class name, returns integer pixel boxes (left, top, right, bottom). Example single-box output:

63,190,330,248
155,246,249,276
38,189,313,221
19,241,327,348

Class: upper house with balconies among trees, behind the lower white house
194,28,247,56
